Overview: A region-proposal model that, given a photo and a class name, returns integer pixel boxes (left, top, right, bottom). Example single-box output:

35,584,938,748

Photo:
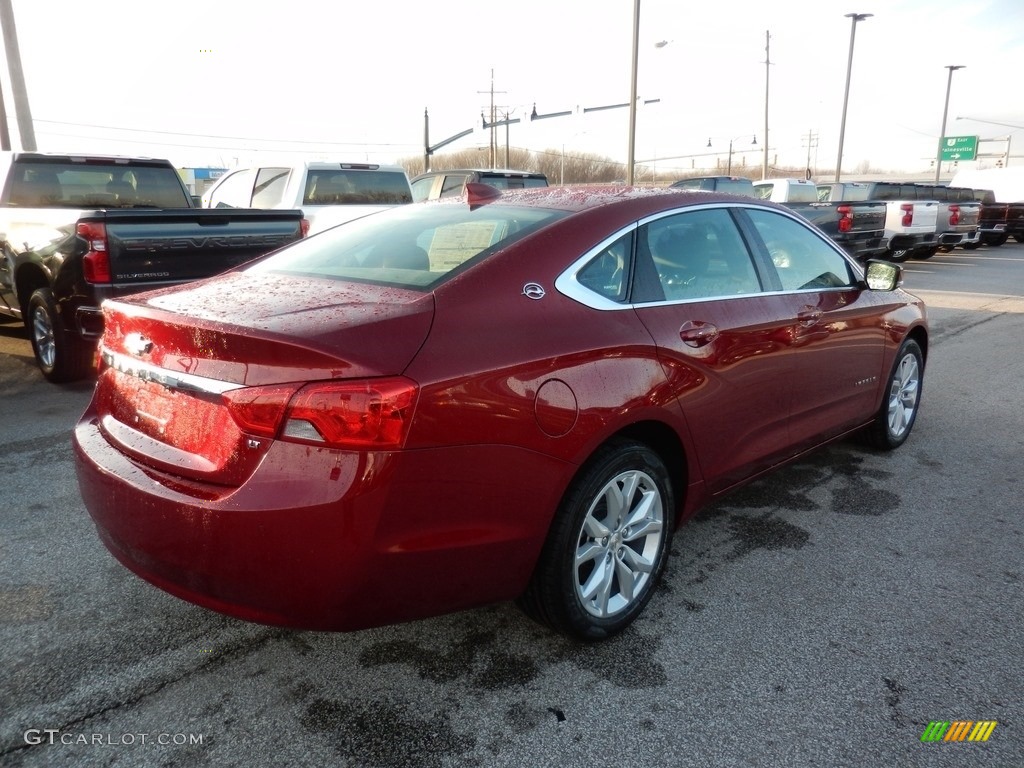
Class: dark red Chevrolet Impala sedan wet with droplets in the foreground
74,185,928,639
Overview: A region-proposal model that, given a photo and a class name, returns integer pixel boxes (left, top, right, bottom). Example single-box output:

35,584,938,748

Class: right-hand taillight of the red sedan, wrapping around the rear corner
223,377,417,450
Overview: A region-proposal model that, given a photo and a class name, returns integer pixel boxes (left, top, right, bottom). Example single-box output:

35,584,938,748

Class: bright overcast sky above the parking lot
2,0,1024,172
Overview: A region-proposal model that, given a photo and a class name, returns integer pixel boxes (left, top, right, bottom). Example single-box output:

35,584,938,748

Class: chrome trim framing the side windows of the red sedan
555,202,864,312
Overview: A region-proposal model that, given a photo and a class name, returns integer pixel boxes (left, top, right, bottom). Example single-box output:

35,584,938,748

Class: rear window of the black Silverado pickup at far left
7,161,191,208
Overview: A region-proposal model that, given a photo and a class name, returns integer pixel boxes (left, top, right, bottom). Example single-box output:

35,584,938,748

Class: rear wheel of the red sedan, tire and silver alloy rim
519,440,675,640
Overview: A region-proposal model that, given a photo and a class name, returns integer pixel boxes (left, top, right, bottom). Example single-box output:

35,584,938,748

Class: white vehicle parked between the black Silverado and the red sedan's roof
203,160,413,234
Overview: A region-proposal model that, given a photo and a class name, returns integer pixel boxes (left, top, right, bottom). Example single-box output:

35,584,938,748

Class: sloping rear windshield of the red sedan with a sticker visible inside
248,203,566,289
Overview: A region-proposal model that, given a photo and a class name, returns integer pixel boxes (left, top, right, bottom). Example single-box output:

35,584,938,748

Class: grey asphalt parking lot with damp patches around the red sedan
0,249,1024,768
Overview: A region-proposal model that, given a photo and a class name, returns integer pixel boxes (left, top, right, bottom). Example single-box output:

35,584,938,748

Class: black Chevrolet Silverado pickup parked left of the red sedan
0,153,304,382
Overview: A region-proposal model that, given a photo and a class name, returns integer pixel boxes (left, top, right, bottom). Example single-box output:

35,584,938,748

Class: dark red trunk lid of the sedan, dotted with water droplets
94,272,433,486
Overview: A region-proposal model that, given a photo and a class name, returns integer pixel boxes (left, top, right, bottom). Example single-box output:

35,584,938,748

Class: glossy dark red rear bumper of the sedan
73,412,569,631
